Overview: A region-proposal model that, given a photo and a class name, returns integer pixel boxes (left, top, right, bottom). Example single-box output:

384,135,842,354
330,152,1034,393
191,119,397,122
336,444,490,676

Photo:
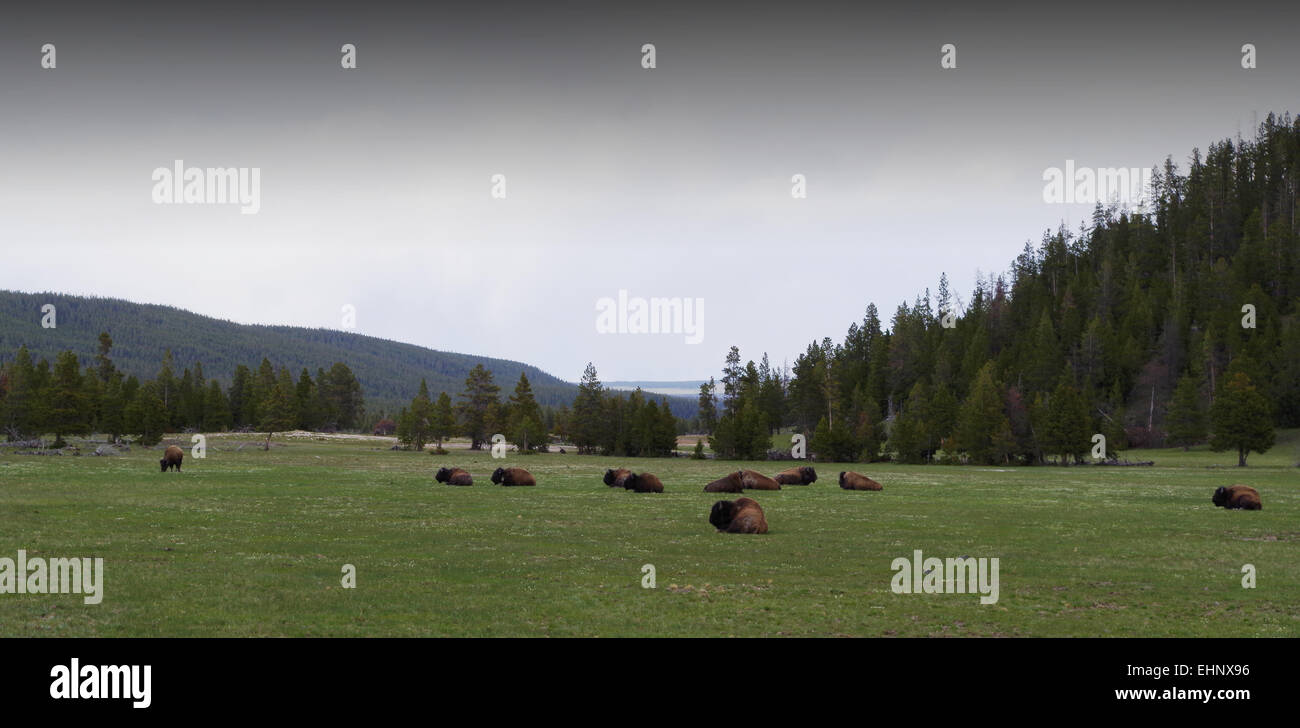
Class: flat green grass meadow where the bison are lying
0,432,1300,637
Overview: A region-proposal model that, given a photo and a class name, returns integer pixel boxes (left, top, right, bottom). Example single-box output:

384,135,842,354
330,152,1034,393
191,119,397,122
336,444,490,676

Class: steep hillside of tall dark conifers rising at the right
702,114,1300,463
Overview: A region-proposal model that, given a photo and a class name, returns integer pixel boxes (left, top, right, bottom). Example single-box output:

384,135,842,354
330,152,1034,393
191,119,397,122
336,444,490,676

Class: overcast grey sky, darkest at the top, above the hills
0,1,1300,380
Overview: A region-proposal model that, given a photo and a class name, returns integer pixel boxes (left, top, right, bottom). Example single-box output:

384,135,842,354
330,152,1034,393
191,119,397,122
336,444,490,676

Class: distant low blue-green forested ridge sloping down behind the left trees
0,291,694,417
